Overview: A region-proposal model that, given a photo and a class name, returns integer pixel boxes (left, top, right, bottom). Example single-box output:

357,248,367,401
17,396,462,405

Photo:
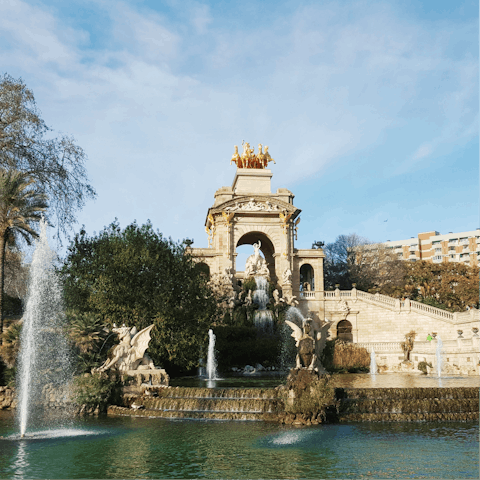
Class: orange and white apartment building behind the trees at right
383,228,480,265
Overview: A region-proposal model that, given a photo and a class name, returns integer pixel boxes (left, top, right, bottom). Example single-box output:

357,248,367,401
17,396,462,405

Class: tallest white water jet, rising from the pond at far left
17,220,73,437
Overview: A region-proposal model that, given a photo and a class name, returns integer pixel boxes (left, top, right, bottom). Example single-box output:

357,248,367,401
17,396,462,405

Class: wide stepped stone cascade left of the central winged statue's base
108,387,283,420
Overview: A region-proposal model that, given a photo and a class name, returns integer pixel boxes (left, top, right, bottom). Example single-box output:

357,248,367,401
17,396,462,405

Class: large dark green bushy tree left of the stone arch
60,222,217,370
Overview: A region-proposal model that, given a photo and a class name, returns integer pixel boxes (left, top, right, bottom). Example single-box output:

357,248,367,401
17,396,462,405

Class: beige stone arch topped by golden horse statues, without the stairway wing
190,144,324,318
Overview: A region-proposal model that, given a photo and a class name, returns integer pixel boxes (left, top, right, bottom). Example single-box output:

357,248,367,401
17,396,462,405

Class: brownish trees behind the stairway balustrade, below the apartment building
324,234,479,312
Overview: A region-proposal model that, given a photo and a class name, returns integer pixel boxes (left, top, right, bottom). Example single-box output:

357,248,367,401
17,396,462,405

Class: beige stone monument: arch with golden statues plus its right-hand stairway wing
188,143,480,375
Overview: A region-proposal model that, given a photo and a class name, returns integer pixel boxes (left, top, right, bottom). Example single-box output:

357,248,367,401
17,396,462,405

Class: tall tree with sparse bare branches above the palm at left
0,74,95,237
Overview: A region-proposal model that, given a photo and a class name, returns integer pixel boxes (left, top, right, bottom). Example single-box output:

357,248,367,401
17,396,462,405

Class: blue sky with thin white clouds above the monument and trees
0,0,480,258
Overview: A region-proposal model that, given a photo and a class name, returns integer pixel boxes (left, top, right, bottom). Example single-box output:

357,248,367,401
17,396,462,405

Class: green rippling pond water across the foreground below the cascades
0,412,479,479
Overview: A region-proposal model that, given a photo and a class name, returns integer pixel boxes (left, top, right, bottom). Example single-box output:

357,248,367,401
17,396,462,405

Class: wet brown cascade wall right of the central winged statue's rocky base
336,387,479,422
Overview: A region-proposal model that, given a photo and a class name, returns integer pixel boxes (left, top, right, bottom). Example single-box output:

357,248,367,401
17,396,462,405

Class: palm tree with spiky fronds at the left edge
0,169,47,345
